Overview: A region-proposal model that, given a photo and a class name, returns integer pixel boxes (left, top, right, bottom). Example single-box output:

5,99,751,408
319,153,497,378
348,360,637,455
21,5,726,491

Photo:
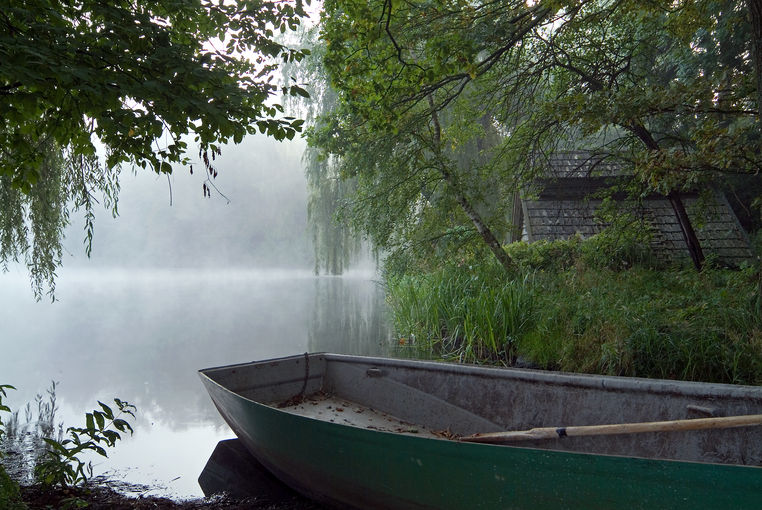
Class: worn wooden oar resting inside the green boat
460,414,762,443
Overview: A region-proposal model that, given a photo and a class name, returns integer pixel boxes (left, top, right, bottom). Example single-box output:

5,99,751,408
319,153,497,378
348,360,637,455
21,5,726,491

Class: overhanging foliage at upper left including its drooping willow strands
0,0,306,295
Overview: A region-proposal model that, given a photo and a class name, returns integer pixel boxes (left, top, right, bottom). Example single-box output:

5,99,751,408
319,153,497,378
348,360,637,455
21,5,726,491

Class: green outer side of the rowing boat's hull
202,354,762,510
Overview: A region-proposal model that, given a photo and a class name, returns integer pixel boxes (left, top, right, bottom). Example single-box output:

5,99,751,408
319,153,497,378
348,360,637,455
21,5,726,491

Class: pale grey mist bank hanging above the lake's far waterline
64,137,312,269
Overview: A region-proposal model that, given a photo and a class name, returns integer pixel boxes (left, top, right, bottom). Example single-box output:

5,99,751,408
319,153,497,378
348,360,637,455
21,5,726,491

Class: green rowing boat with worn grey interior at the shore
200,353,762,510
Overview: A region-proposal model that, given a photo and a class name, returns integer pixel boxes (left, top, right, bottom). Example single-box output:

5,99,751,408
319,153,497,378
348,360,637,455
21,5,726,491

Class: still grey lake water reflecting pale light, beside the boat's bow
0,269,392,498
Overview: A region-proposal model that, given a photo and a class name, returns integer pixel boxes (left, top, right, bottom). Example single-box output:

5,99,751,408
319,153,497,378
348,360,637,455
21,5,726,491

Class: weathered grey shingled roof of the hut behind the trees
522,152,752,265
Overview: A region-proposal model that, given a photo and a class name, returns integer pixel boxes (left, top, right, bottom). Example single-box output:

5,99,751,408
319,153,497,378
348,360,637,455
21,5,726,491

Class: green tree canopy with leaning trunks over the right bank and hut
316,0,761,274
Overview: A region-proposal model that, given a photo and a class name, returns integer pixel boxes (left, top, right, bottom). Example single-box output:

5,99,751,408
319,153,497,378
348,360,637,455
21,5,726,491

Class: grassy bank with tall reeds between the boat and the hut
387,239,762,384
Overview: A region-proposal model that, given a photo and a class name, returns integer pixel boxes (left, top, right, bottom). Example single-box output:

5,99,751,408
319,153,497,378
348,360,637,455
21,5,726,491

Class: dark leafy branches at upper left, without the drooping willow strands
0,0,305,190
